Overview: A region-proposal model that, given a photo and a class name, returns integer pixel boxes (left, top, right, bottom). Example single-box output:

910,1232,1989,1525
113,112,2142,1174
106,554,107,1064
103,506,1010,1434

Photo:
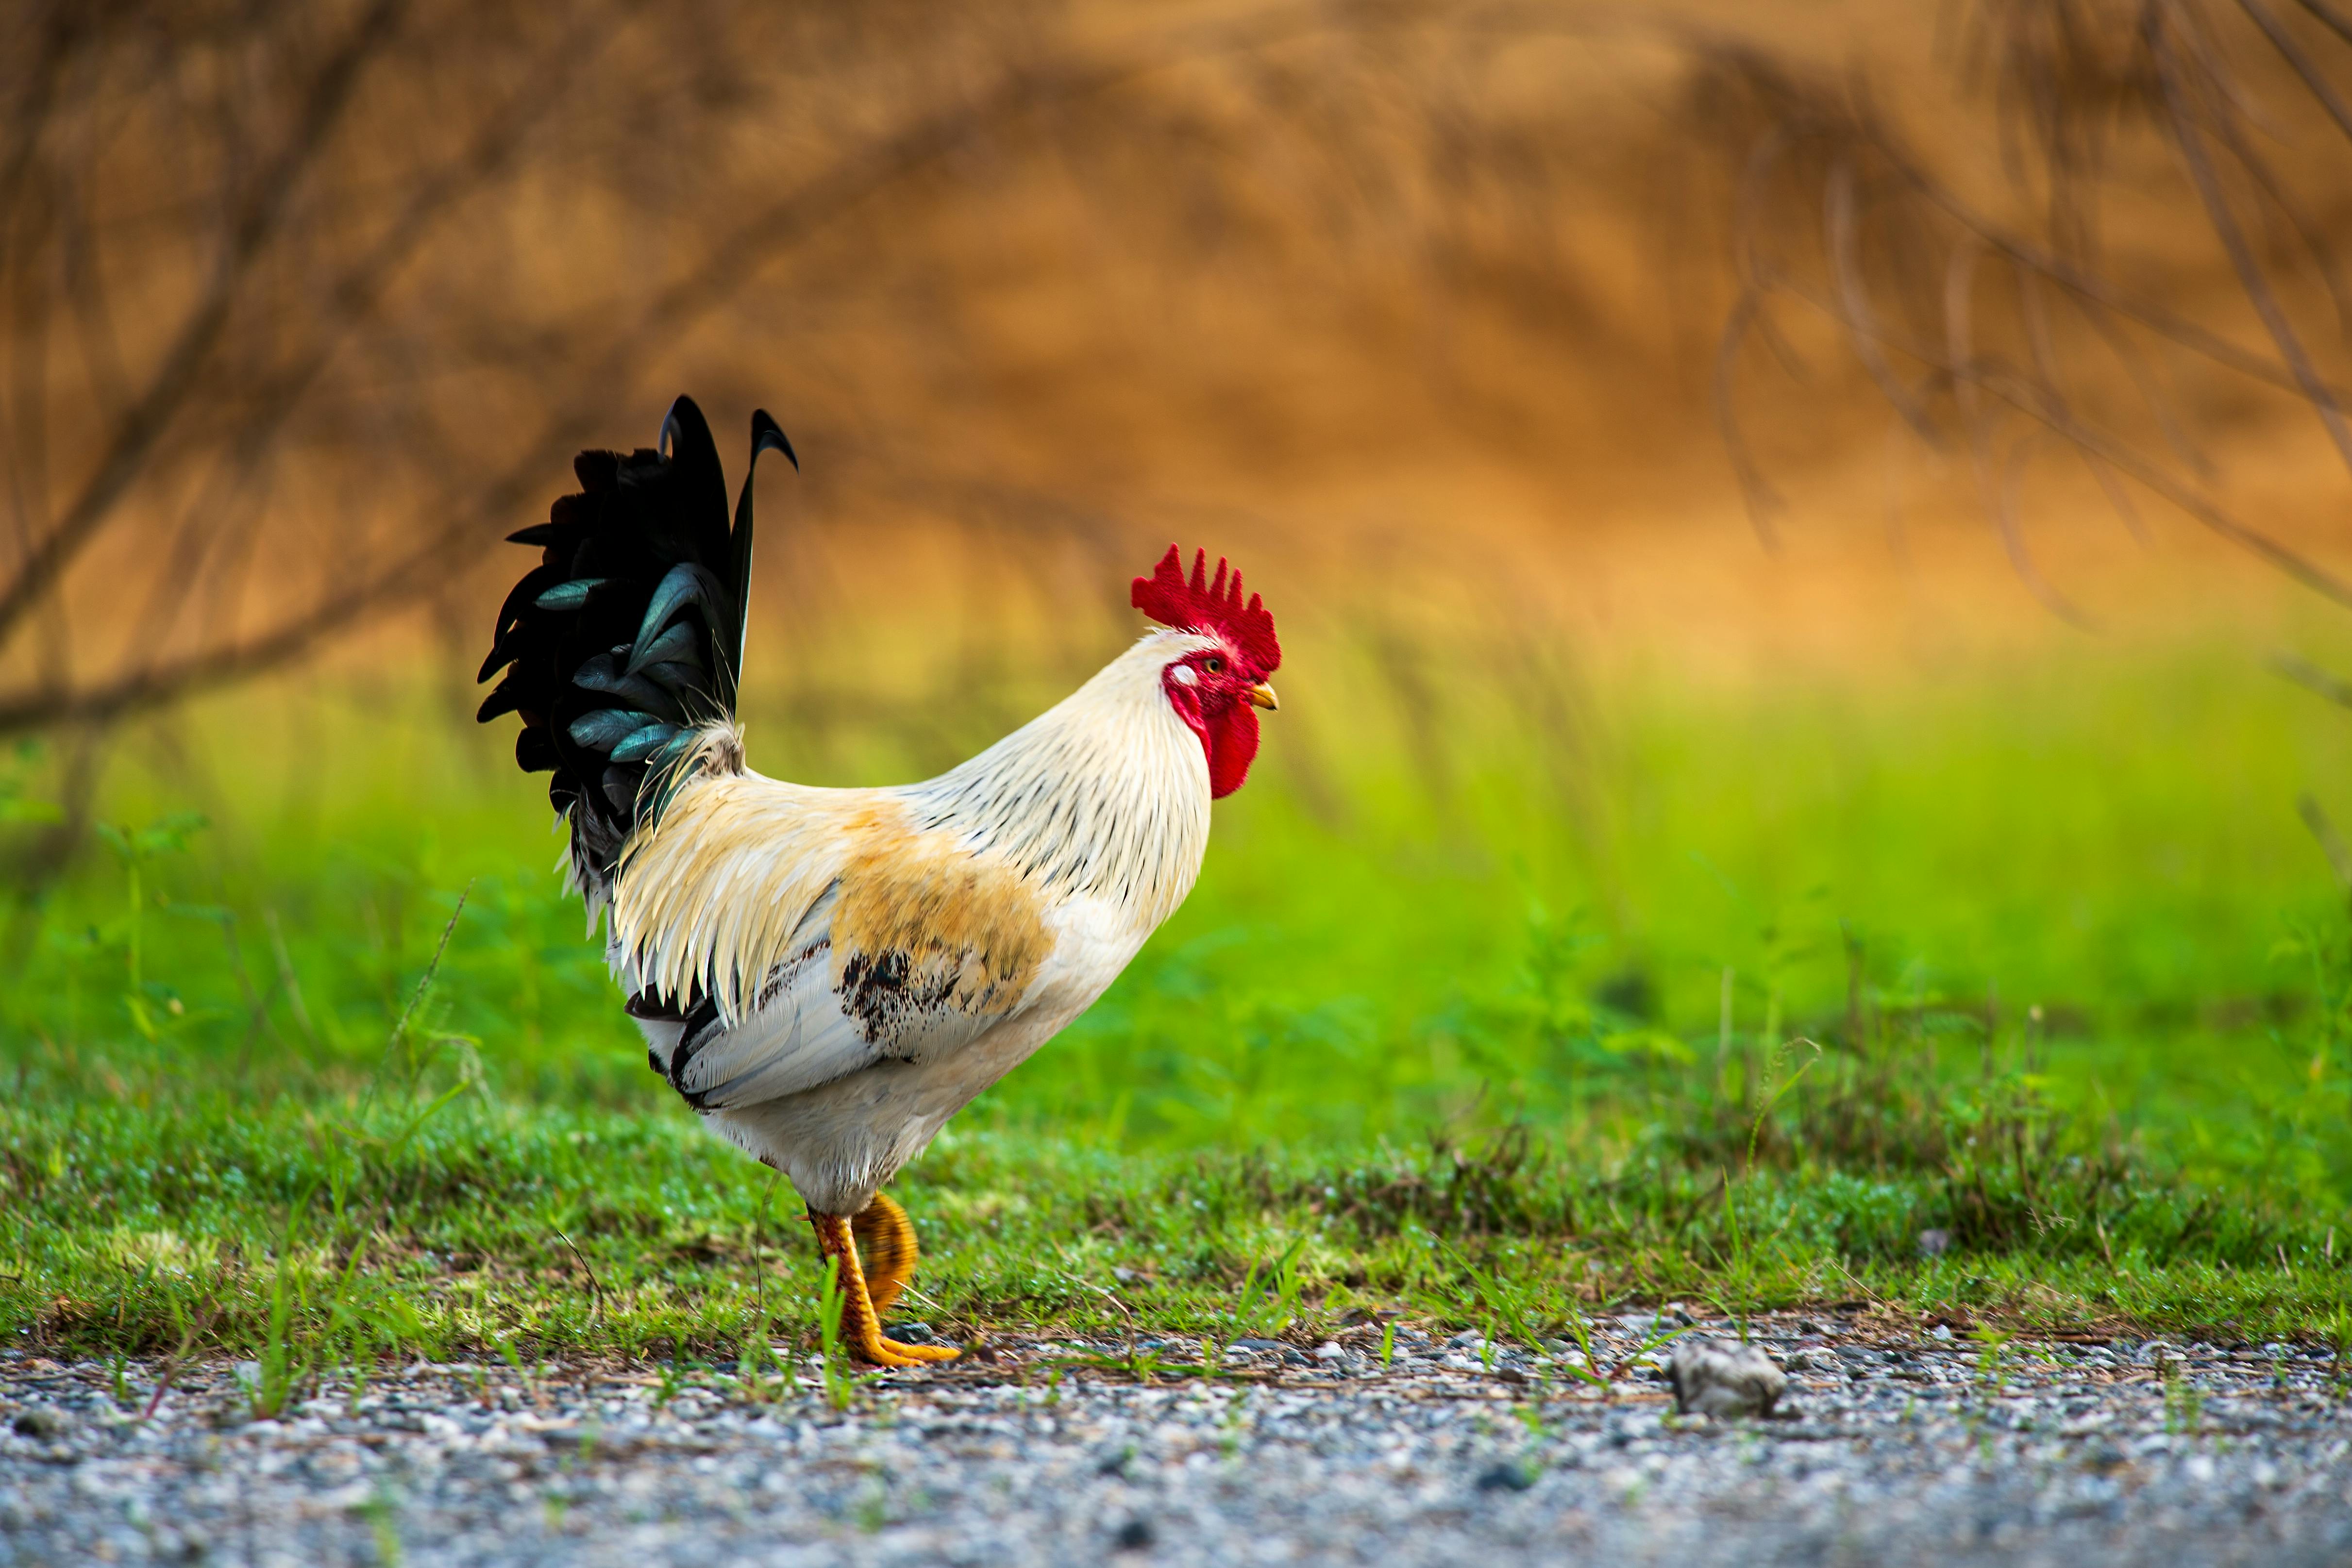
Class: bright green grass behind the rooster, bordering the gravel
0,630,2352,1403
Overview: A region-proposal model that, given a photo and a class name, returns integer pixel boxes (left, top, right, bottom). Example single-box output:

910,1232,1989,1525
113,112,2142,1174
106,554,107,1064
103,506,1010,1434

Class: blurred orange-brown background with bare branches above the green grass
14,0,2352,790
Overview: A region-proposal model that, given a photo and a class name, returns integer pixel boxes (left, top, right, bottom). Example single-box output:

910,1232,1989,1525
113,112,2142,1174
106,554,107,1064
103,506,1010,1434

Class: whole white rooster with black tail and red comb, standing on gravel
480,397,1282,1366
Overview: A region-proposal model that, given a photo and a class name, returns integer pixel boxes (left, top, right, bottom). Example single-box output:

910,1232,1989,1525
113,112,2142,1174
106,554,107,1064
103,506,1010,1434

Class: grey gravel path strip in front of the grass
0,1317,2352,1568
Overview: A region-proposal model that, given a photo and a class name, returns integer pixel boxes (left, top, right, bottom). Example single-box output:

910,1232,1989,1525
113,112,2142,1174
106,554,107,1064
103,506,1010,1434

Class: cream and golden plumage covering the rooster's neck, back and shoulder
611,633,1211,1027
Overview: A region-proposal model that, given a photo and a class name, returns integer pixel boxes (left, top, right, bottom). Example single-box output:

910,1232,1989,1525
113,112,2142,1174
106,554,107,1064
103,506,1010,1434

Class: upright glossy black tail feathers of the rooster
477,397,800,874
